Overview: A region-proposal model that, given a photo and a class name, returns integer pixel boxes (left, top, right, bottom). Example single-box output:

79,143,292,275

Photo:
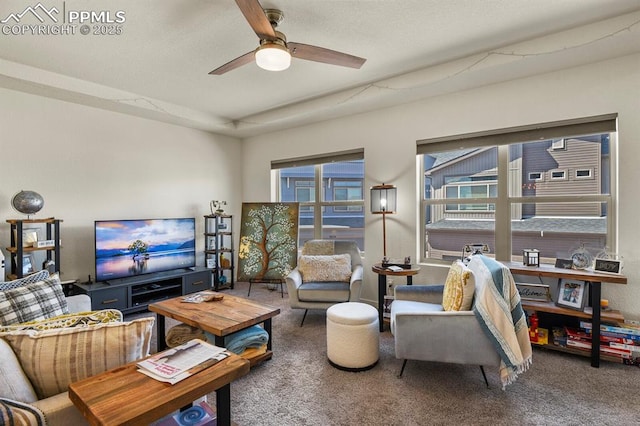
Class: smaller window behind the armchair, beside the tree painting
271,150,364,251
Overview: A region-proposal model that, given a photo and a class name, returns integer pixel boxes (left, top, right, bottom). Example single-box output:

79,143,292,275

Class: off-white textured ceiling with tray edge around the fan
0,0,640,137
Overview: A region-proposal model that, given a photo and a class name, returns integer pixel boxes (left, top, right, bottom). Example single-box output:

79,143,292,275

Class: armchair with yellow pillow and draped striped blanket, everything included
391,255,531,388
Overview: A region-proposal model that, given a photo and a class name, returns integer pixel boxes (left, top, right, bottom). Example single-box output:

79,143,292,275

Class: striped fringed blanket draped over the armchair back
469,255,532,389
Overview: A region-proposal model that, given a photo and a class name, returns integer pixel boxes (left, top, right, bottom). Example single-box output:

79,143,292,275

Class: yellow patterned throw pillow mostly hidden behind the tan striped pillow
0,309,122,332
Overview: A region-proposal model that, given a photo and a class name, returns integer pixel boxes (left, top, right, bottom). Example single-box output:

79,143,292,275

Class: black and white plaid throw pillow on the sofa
0,274,69,325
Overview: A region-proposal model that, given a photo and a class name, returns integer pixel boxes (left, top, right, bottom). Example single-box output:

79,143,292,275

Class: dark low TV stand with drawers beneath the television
74,267,211,314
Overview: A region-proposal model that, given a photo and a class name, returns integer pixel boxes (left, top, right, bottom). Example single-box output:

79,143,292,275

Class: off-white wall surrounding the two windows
242,54,640,319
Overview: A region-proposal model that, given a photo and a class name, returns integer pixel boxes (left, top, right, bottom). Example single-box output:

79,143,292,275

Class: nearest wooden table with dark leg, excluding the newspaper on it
69,354,249,425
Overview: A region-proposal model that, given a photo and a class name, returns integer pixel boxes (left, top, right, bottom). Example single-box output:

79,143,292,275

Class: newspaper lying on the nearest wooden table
138,339,229,385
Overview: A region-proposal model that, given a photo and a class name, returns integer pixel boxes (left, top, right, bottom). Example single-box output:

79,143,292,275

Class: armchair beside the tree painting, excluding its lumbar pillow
286,240,363,327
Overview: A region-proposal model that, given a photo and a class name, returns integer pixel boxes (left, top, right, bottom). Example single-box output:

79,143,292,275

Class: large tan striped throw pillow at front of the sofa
0,317,155,399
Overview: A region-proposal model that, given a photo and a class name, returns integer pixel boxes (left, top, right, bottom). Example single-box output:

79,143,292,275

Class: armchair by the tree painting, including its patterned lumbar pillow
286,240,363,327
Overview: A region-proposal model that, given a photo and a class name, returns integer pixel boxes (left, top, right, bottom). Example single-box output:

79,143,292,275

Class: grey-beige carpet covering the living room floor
129,283,640,426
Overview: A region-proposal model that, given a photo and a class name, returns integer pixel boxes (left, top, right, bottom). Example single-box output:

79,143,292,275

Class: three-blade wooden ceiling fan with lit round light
209,0,366,75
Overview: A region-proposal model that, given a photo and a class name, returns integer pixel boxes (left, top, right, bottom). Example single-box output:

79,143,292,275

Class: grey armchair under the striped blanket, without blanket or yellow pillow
391,268,500,386
